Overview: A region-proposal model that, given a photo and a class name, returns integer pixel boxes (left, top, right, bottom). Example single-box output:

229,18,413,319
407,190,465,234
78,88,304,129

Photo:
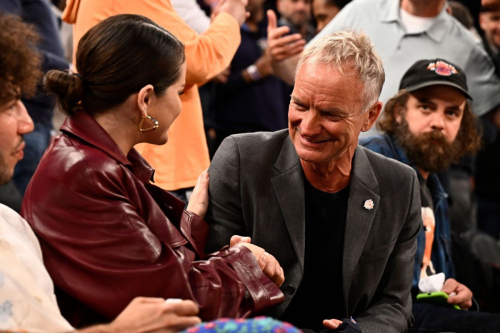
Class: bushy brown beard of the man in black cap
395,115,462,173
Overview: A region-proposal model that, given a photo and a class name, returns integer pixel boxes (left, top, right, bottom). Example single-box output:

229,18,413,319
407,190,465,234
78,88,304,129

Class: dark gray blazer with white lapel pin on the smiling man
205,130,422,333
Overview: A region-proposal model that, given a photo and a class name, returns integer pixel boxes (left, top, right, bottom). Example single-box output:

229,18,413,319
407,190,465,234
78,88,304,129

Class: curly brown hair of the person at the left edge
0,13,42,104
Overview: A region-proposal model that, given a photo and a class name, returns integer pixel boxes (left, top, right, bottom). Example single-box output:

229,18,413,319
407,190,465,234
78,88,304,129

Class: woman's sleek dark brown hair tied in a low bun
44,14,185,115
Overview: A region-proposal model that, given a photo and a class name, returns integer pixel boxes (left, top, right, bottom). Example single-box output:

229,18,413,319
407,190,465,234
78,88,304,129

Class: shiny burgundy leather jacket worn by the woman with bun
22,112,283,327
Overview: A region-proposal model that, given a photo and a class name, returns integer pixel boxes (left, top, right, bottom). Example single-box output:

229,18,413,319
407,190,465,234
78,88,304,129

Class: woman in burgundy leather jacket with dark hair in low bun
22,15,283,327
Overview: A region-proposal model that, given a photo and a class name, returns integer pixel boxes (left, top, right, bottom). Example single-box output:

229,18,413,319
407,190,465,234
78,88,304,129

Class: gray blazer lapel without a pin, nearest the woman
271,136,306,270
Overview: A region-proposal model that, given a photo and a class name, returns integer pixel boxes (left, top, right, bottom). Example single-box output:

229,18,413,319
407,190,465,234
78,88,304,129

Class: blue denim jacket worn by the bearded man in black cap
359,134,454,287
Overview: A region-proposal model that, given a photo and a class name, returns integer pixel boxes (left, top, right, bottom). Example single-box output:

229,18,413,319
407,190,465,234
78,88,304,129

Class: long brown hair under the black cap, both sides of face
377,89,481,155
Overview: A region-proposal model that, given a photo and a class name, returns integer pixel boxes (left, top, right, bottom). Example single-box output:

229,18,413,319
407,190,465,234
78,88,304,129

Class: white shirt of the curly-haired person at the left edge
0,204,74,333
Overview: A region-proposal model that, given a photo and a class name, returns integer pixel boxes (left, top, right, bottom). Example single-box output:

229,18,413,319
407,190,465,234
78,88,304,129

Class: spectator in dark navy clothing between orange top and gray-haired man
208,0,292,152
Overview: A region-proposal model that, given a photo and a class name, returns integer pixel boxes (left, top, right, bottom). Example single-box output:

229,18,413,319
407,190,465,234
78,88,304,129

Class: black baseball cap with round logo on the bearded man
399,59,472,100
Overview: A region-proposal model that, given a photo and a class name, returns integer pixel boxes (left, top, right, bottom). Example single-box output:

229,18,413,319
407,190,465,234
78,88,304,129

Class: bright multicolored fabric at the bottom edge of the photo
181,317,302,333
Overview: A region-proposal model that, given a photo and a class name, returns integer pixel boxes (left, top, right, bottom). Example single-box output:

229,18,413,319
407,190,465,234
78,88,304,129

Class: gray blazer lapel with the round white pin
342,146,380,309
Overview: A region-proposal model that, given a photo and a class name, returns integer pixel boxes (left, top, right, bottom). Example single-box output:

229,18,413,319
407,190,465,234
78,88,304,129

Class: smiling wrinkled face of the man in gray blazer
288,62,368,166
